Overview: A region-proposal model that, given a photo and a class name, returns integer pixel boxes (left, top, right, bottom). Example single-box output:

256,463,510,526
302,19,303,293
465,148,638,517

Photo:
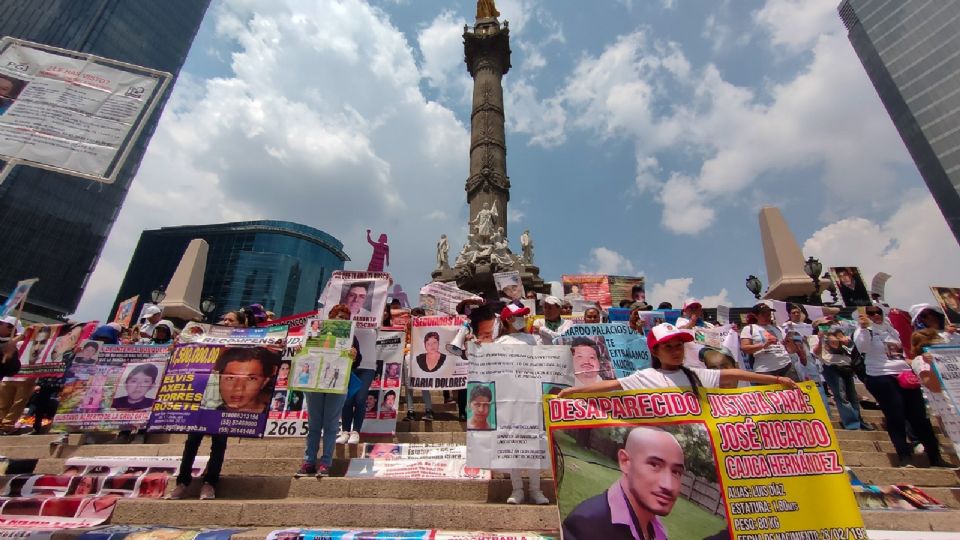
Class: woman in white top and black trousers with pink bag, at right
853,306,948,467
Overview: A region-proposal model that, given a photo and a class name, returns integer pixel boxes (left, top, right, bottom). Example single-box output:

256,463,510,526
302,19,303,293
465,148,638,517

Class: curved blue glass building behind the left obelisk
113,221,350,317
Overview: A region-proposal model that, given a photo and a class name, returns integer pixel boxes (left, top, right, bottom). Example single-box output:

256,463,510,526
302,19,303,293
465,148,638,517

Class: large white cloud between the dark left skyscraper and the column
72,0,469,318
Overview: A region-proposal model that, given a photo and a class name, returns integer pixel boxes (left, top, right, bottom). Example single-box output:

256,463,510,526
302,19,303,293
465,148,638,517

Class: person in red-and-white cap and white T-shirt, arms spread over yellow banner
559,323,797,397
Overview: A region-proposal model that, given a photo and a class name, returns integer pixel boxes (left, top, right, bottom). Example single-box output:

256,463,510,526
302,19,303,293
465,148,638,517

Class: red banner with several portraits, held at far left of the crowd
17,321,98,378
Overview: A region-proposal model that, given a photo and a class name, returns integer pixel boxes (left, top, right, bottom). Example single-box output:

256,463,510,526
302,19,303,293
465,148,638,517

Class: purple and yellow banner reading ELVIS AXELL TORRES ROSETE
147,323,287,437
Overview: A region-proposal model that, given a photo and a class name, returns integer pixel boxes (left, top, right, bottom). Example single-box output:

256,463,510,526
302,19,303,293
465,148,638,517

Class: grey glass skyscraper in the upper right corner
839,0,960,242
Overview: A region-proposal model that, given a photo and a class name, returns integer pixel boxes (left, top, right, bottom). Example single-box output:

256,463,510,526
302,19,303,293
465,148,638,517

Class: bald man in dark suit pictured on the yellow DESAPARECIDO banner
563,427,684,540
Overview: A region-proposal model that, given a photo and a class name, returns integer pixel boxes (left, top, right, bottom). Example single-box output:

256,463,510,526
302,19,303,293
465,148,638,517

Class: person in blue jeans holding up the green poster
296,304,358,478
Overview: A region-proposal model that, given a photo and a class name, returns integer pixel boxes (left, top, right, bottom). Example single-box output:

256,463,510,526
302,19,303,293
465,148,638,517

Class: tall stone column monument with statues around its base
432,0,547,299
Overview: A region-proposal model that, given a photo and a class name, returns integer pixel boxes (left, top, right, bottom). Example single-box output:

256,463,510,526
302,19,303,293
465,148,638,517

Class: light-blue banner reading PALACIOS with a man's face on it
561,323,650,386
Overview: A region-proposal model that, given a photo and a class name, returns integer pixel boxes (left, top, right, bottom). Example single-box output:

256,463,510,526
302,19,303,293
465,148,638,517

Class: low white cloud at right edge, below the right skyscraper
803,190,960,309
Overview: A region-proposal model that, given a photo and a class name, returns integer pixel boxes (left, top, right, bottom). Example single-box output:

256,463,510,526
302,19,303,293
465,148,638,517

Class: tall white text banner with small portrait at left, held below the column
467,344,573,469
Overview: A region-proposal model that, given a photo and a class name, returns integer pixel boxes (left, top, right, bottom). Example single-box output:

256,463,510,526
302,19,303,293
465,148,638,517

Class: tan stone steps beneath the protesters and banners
0,393,960,540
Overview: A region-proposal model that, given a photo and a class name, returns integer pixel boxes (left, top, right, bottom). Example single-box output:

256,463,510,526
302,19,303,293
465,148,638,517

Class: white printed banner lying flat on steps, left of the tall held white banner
346,443,490,480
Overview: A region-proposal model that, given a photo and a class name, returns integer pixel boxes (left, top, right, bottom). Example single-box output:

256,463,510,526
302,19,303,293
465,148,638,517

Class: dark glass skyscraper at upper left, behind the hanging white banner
0,0,210,317
